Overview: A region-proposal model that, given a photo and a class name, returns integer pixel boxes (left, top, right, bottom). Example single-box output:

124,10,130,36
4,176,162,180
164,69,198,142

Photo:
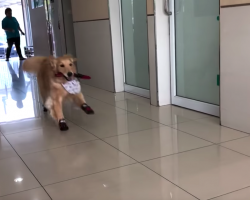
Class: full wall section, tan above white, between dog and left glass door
71,0,115,92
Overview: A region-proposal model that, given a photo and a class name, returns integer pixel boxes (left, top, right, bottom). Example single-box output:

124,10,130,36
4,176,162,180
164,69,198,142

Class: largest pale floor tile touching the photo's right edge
143,145,250,200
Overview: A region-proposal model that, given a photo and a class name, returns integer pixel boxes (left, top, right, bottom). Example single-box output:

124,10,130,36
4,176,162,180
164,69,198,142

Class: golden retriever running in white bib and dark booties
23,55,94,131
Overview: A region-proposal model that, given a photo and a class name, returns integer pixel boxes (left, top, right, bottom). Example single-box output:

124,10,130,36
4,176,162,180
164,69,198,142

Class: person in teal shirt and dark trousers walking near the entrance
2,8,25,61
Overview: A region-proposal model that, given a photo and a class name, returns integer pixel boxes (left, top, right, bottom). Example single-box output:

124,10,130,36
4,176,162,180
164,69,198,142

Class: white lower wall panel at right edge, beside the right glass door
220,5,250,133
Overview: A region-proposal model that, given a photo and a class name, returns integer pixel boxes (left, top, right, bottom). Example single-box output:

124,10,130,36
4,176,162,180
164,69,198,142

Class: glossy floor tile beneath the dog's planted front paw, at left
6,122,97,154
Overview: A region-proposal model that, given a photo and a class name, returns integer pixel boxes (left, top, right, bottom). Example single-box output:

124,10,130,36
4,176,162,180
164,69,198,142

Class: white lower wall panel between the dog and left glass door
74,20,114,92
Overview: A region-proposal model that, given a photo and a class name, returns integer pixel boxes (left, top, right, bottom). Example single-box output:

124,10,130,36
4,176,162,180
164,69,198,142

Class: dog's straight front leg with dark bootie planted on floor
51,99,69,131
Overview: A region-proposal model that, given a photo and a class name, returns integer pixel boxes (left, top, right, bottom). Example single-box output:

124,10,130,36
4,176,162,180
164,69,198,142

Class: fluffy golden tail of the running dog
22,56,46,74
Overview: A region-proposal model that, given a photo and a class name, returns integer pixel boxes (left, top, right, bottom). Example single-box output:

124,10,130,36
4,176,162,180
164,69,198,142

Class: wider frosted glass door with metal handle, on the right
169,0,220,116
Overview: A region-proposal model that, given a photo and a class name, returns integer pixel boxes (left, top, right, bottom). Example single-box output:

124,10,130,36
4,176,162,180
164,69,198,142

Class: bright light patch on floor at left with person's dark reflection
0,59,38,123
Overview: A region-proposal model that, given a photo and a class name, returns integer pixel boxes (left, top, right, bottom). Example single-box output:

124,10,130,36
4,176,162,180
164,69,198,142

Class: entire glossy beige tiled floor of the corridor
0,61,250,200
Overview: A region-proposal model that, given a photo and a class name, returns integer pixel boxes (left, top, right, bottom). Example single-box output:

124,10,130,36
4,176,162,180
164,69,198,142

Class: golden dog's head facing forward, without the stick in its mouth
51,55,76,81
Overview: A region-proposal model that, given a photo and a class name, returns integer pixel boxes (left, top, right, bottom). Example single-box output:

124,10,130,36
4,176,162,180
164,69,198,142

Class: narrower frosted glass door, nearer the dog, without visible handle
120,0,150,97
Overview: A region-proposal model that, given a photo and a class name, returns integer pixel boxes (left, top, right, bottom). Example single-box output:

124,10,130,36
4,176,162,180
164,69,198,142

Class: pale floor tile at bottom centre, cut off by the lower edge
45,164,196,200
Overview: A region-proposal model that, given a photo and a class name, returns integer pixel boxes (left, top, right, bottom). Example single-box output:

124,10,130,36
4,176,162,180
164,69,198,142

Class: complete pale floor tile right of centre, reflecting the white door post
105,127,212,161
